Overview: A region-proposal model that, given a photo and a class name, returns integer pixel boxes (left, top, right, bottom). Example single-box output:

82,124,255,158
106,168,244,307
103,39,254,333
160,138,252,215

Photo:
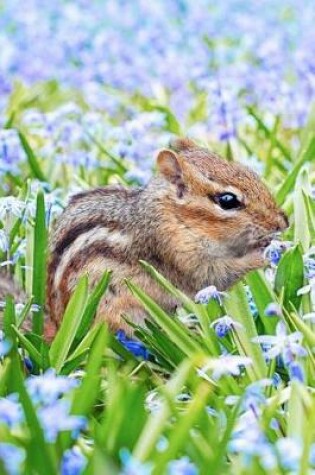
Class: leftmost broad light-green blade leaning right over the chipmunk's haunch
49,276,88,372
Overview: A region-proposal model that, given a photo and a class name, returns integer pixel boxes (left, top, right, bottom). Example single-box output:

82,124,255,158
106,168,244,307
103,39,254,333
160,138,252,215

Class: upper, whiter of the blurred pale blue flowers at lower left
26,369,79,404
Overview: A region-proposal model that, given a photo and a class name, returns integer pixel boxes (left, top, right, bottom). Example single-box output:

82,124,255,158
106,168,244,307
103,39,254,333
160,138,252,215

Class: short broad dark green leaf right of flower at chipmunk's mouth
275,244,304,310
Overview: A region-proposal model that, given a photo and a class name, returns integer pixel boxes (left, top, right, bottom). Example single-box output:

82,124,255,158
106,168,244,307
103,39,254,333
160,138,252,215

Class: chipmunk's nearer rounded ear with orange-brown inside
156,150,185,198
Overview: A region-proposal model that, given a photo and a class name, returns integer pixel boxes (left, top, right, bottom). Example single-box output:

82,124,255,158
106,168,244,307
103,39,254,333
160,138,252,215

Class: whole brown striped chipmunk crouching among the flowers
46,139,288,338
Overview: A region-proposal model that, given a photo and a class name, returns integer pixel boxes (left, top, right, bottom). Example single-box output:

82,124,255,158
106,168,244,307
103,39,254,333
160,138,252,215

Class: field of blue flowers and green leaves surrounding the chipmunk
0,0,315,475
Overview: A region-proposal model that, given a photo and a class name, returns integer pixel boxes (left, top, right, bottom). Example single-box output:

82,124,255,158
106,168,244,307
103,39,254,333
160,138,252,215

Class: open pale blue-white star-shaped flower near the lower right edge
253,321,307,364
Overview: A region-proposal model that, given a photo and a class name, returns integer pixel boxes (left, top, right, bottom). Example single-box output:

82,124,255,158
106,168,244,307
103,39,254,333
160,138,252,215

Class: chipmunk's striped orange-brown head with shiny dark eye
157,139,288,258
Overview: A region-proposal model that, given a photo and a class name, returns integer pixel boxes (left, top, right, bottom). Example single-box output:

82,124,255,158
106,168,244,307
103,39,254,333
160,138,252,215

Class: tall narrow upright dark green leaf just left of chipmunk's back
32,190,47,335
